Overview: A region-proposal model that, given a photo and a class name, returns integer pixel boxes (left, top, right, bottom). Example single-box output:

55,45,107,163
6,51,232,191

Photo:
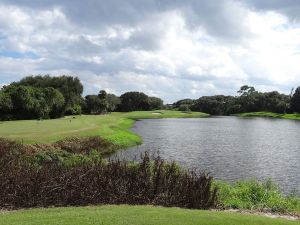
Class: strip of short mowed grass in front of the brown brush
0,205,300,225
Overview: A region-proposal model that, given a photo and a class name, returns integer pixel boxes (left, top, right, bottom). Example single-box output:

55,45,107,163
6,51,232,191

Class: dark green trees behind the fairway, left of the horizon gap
0,75,163,120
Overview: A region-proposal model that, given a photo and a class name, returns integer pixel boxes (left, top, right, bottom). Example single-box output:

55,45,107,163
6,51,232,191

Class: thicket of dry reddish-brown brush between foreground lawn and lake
0,140,217,209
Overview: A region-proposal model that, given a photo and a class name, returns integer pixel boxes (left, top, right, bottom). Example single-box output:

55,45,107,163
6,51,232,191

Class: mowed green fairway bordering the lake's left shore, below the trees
0,110,207,147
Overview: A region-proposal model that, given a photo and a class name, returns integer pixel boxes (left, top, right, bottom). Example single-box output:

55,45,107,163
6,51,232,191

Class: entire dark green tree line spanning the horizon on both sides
0,75,300,120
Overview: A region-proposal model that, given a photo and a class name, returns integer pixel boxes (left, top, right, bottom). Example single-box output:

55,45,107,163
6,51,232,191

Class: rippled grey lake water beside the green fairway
112,117,300,194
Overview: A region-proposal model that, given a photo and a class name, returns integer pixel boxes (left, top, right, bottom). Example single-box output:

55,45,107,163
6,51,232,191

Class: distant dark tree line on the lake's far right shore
174,85,300,115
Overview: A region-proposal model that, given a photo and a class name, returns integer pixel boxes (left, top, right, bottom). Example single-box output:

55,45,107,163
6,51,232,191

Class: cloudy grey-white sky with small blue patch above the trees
0,0,300,103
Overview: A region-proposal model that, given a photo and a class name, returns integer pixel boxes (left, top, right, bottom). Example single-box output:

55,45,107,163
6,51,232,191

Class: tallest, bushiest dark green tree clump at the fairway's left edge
0,75,83,120
